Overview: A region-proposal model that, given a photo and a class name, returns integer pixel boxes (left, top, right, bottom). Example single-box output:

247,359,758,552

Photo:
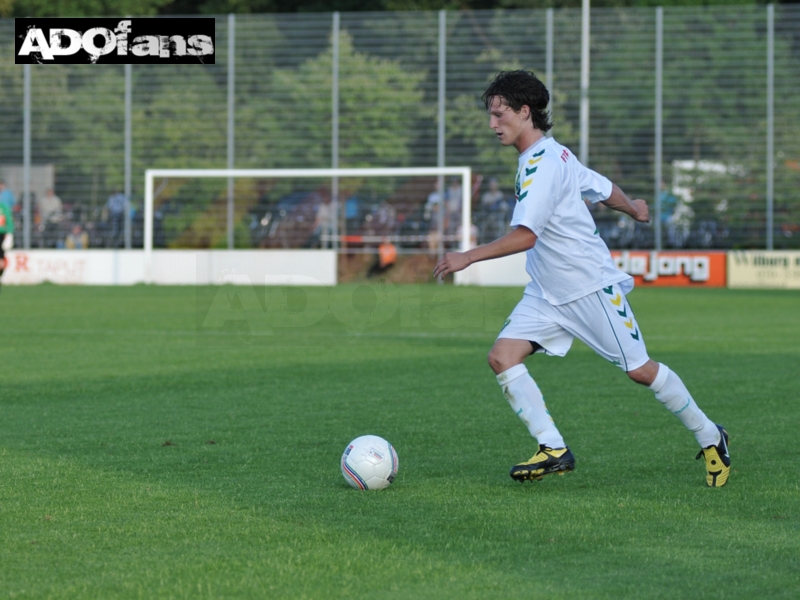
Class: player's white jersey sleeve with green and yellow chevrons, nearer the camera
511,155,561,236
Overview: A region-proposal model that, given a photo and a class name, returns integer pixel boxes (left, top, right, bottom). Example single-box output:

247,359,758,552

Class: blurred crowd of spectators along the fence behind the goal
0,175,780,253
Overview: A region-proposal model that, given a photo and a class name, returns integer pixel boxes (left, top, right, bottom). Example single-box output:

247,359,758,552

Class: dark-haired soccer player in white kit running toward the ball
434,71,730,487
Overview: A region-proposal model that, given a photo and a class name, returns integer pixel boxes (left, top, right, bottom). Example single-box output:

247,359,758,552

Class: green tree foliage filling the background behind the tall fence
0,0,800,245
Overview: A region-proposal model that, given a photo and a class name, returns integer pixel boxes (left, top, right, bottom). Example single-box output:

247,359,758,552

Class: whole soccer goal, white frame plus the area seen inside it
143,167,475,282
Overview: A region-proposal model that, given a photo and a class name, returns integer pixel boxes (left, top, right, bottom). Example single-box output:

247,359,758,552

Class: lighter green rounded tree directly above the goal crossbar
253,31,428,168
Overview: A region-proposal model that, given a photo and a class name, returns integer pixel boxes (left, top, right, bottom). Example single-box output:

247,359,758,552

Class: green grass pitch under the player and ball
0,285,800,600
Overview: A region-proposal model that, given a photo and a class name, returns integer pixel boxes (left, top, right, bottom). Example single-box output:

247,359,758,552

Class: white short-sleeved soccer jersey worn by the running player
511,137,633,305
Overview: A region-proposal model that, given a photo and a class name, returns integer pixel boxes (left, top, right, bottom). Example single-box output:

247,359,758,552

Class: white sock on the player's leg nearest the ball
497,365,566,448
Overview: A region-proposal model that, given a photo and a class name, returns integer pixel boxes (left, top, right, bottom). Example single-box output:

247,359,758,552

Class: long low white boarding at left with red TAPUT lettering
2,250,337,285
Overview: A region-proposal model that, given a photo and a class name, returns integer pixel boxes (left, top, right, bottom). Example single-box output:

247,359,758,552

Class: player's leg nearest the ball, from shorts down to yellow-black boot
489,296,575,481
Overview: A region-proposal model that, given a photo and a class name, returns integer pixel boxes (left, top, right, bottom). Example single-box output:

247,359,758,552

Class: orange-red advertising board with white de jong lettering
611,250,727,287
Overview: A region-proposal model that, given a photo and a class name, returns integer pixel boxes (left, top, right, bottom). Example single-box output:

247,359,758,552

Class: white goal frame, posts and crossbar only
144,167,472,281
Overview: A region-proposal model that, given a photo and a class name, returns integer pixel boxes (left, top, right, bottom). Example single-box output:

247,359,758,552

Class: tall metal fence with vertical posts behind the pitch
0,5,800,249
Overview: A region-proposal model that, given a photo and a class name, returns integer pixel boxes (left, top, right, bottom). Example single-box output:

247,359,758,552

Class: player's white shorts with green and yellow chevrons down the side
497,284,649,372
